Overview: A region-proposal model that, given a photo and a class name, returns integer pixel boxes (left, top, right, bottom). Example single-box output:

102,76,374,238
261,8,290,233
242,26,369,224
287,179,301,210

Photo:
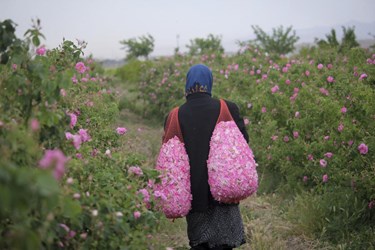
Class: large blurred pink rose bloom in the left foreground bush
39,149,68,180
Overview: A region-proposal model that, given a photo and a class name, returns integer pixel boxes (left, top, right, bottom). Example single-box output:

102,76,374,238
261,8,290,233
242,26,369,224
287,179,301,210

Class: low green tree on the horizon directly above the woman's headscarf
186,34,224,55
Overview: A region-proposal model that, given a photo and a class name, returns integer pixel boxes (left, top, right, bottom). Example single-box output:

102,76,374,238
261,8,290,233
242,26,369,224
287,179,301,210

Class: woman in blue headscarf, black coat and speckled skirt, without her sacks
164,64,249,249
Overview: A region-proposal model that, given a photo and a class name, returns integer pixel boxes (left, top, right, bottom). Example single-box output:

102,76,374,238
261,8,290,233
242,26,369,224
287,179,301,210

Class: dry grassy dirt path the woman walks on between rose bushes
117,79,332,250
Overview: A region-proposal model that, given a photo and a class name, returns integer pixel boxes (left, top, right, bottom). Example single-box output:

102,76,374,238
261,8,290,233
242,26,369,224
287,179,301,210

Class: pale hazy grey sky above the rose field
0,0,375,59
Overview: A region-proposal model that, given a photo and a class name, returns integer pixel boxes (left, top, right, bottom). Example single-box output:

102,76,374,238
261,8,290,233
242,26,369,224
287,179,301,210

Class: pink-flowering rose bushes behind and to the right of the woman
117,46,375,249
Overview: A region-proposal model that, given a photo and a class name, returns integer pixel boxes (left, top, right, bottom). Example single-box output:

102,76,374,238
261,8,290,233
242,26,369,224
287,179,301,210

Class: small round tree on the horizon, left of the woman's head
120,34,155,60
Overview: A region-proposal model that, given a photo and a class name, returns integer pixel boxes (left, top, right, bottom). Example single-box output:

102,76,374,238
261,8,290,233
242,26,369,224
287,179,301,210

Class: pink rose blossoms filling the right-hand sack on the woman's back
207,121,258,203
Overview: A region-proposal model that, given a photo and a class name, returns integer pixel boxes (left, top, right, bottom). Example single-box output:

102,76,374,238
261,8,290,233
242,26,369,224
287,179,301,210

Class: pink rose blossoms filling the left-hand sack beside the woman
154,136,192,218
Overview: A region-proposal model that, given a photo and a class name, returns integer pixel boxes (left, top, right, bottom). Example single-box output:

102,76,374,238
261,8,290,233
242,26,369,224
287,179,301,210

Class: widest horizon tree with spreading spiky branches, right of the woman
251,25,299,55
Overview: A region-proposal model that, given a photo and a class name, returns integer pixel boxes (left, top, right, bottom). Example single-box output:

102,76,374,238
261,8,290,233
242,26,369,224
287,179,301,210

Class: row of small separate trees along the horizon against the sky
120,25,373,60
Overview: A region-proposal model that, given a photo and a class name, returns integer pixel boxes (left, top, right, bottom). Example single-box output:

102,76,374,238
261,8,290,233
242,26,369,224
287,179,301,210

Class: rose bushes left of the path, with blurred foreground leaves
0,20,160,249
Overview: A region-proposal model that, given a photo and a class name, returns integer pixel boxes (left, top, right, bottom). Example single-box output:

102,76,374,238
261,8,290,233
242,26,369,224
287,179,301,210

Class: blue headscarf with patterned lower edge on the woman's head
185,64,213,96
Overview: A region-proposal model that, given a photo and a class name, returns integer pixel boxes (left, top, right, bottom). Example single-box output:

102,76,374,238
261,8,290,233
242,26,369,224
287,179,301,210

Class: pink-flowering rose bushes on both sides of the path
0,16,375,249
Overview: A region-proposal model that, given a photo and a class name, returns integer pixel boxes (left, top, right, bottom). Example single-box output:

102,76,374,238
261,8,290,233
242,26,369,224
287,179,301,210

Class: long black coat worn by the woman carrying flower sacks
164,93,249,212
